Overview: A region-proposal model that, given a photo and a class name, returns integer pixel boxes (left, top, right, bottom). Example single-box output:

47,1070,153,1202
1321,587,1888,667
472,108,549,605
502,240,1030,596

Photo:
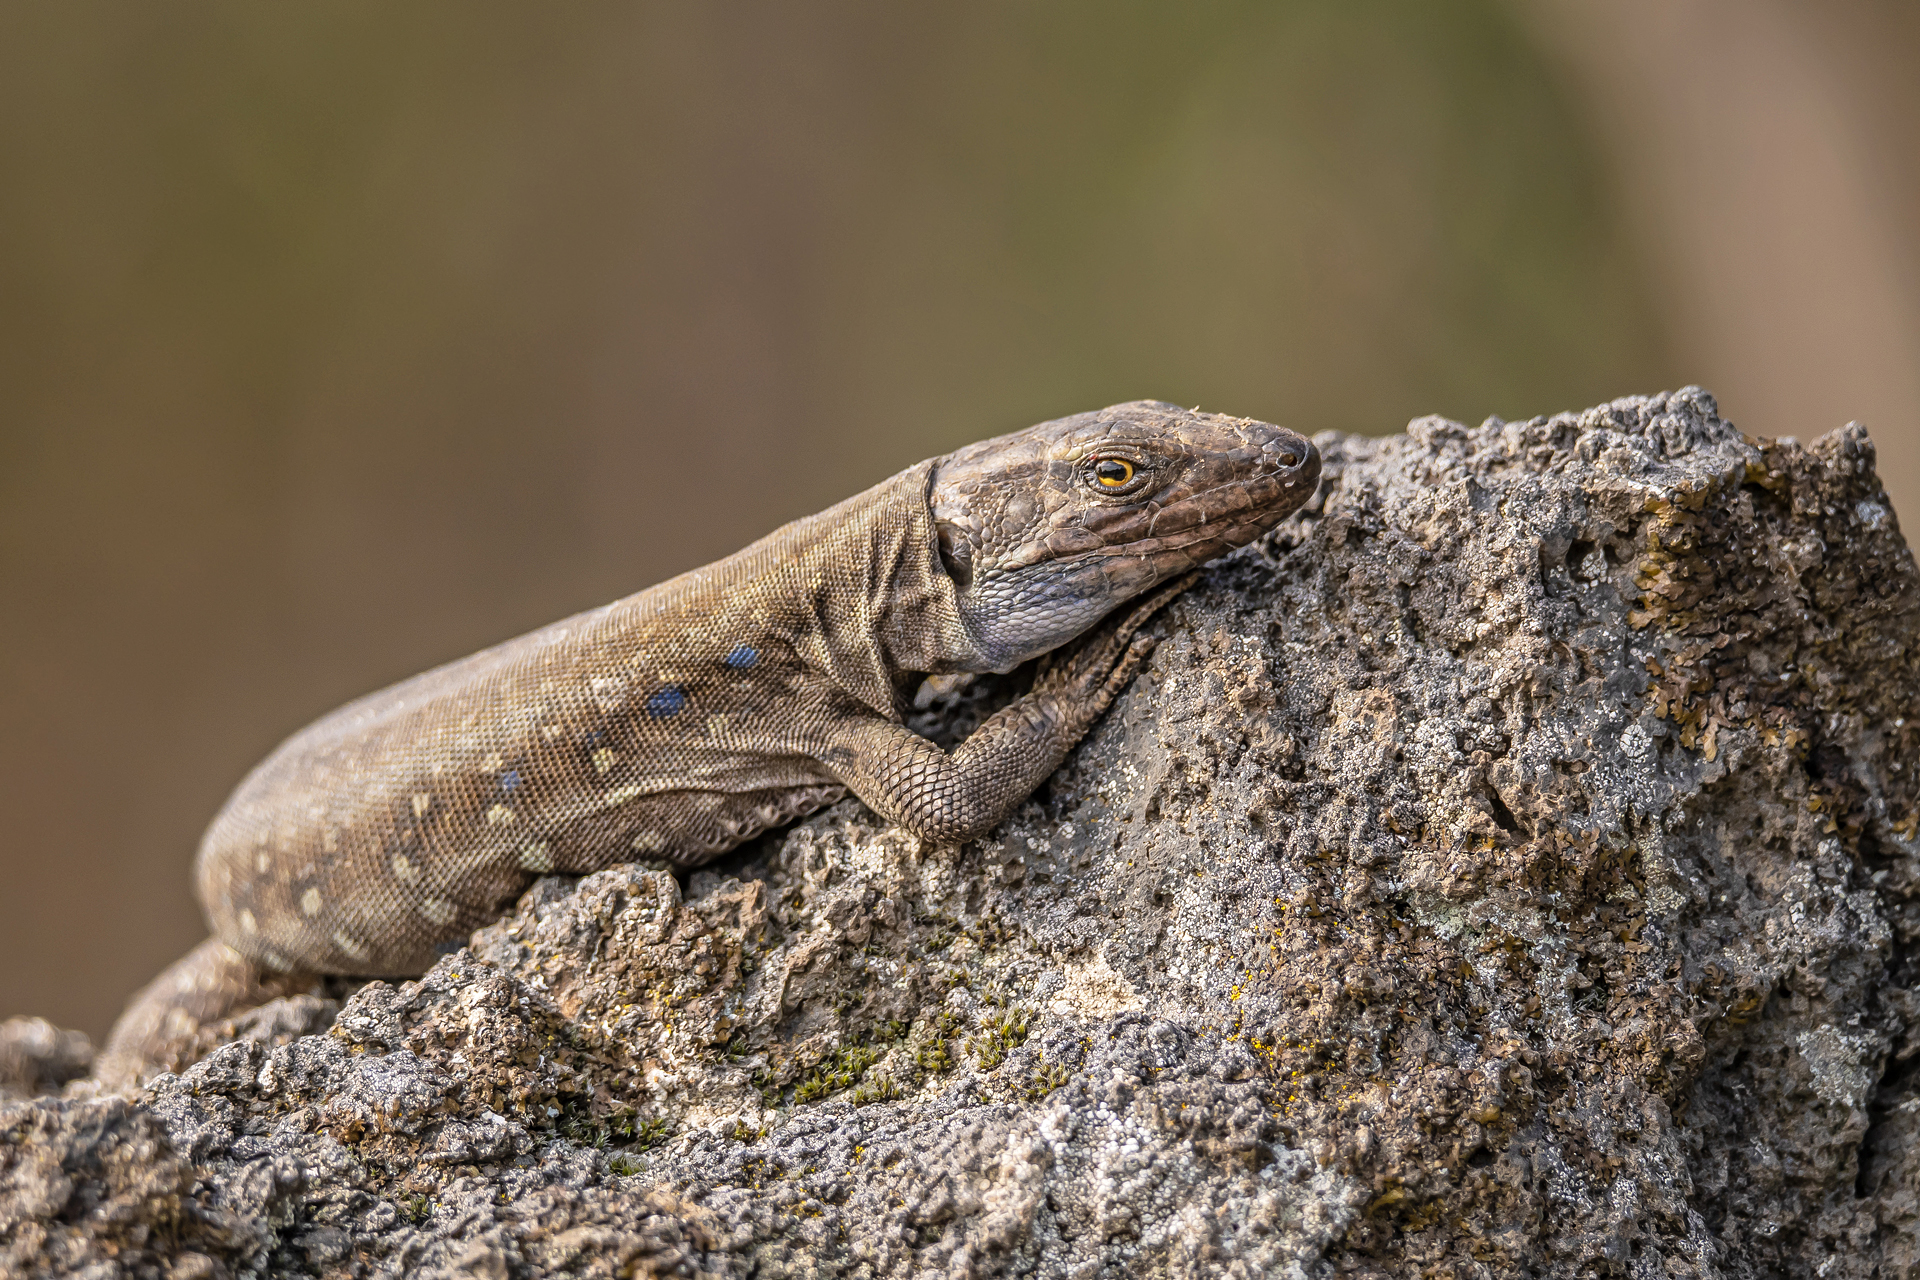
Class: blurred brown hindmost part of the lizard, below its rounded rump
94,938,313,1092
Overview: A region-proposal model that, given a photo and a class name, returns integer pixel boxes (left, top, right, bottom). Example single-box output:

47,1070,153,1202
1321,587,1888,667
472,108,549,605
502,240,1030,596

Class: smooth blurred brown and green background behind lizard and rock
11,0,1920,1036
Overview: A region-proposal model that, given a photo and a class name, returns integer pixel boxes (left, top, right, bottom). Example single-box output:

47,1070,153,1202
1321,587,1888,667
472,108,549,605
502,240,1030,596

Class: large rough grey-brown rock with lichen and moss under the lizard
0,390,1920,1276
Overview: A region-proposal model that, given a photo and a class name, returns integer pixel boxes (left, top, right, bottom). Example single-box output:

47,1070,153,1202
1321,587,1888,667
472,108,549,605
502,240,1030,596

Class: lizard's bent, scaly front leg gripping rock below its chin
822,574,1194,844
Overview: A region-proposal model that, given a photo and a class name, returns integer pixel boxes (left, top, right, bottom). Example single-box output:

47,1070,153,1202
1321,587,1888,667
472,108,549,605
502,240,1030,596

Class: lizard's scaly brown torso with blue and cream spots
196,462,968,975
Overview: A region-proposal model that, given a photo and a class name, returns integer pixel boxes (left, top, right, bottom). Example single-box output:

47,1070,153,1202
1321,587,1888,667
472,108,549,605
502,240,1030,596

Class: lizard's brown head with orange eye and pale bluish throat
929,401,1319,670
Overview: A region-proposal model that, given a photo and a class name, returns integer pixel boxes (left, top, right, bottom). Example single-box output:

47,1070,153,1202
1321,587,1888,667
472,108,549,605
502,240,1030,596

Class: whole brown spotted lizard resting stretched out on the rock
96,401,1319,1079
